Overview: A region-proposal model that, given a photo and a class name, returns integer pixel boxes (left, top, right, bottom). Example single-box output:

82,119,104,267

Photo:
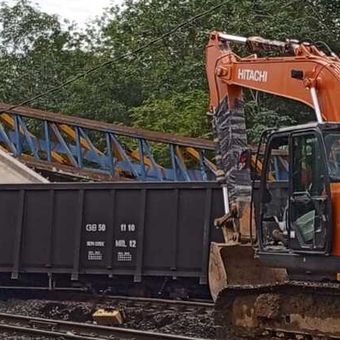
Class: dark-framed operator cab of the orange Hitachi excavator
255,123,340,274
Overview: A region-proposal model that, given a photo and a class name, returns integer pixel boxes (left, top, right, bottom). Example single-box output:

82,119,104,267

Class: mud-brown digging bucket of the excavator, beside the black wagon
209,243,287,301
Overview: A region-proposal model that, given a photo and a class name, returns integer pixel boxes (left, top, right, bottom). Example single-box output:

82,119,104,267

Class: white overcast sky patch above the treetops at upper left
5,0,123,26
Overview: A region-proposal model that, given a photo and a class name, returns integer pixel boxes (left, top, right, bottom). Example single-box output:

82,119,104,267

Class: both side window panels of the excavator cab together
258,130,330,252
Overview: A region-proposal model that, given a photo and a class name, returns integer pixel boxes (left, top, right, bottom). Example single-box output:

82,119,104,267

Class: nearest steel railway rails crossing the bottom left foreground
0,313,210,340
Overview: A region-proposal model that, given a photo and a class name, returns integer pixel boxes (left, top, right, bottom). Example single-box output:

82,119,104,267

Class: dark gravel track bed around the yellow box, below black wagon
0,290,215,339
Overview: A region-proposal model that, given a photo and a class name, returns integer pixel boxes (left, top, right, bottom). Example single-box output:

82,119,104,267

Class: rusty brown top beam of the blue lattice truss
0,103,214,150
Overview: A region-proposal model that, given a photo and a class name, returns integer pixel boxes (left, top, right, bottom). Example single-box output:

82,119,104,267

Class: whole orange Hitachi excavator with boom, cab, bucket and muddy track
206,32,340,338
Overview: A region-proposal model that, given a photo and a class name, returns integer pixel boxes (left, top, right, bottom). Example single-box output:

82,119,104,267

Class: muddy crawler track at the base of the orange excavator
214,281,340,339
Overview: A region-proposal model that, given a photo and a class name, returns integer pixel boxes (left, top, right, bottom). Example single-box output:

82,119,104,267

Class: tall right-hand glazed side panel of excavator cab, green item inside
289,132,328,251
